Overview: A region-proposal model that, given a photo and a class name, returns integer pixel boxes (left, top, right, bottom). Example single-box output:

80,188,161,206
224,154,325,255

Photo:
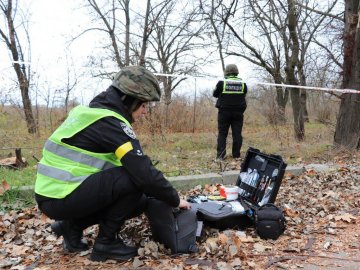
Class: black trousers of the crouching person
38,167,147,238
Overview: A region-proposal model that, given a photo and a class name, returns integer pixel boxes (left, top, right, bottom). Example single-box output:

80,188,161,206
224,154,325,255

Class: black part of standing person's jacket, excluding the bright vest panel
213,78,247,112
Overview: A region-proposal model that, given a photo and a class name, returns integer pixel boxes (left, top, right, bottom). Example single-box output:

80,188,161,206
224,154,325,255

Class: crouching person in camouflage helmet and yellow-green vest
35,66,190,261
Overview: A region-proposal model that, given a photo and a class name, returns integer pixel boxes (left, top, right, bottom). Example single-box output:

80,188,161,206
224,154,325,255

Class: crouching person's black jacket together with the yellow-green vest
35,87,180,207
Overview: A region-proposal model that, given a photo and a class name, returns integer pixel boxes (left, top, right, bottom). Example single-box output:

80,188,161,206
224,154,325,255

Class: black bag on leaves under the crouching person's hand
145,198,198,254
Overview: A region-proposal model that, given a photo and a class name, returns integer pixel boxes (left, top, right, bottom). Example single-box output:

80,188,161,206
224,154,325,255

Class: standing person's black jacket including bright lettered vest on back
213,76,247,112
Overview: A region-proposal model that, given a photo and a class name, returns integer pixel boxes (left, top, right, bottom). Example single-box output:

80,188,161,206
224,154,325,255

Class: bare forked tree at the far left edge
0,0,37,134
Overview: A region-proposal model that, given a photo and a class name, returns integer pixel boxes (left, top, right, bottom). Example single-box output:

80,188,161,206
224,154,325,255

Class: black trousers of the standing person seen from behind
216,109,244,158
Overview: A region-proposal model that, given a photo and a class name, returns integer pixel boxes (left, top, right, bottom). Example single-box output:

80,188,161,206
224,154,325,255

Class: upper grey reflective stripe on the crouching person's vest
44,140,115,171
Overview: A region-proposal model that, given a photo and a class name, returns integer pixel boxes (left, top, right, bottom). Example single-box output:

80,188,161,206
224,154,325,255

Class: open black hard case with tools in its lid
188,147,287,230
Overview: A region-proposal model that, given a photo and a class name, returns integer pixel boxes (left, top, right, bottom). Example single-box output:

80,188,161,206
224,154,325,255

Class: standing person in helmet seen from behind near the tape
213,64,247,160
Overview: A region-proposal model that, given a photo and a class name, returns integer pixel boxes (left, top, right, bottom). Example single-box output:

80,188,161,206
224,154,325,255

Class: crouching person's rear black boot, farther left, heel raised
51,220,89,252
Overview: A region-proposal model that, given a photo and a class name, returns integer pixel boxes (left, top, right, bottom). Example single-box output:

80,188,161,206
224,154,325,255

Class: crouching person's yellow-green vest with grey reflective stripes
35,105,131,198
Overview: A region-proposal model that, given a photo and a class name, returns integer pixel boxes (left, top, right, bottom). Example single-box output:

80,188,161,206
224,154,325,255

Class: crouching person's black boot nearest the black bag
90,237,137,262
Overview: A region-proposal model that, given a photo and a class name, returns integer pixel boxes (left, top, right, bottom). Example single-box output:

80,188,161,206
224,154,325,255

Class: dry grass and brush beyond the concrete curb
0,92,358,185
